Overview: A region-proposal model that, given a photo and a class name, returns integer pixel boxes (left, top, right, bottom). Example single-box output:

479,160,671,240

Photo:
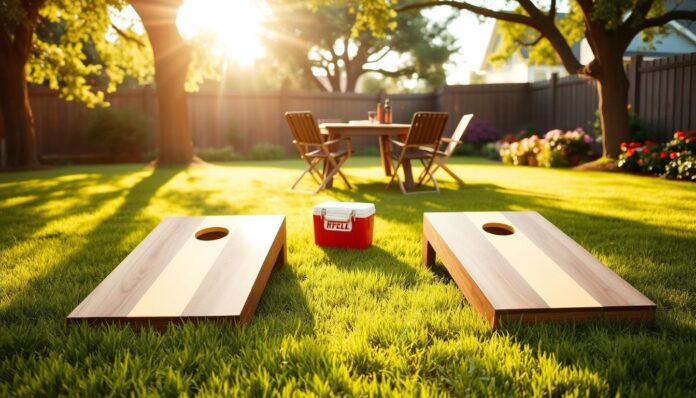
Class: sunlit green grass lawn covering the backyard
0,158,696,396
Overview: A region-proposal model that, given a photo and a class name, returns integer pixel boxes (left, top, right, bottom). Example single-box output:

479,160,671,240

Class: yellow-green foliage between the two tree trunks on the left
26,0,154,107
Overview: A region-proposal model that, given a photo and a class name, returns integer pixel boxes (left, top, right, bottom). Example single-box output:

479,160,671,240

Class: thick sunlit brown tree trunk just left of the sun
131,0,193,164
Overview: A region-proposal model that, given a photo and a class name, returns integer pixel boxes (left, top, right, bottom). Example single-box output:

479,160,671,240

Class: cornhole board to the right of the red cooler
423,211,655,329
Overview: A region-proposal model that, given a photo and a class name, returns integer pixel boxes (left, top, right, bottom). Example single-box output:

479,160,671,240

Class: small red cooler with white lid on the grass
314,202,375,249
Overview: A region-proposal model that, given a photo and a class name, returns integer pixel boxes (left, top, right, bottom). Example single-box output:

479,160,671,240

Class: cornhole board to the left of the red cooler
67,215,286,329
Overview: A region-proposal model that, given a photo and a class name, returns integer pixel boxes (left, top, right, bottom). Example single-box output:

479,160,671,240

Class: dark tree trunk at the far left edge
0,5,39,168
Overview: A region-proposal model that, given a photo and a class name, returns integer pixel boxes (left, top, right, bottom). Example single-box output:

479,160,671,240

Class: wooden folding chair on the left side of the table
285,111,353,193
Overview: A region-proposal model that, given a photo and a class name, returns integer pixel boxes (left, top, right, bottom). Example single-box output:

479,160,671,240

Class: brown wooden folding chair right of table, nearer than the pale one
387,112,447,194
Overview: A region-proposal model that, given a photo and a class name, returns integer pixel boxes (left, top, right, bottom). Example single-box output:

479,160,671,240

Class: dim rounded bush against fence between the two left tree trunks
84,108,152,155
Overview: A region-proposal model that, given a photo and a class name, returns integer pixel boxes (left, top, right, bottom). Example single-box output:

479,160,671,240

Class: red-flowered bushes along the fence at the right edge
618,130,696,182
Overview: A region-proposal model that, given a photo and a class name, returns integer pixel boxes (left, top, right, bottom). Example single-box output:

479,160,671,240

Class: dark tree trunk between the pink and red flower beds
597,59,631,159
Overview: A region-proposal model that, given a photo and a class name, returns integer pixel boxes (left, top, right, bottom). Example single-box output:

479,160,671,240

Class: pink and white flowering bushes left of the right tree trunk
496,128,594,167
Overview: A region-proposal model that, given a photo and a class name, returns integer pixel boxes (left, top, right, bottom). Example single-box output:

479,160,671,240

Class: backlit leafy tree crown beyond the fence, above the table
267,0,457,91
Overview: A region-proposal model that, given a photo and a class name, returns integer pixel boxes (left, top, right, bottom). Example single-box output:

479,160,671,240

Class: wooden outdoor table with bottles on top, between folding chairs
319,122,414,189
